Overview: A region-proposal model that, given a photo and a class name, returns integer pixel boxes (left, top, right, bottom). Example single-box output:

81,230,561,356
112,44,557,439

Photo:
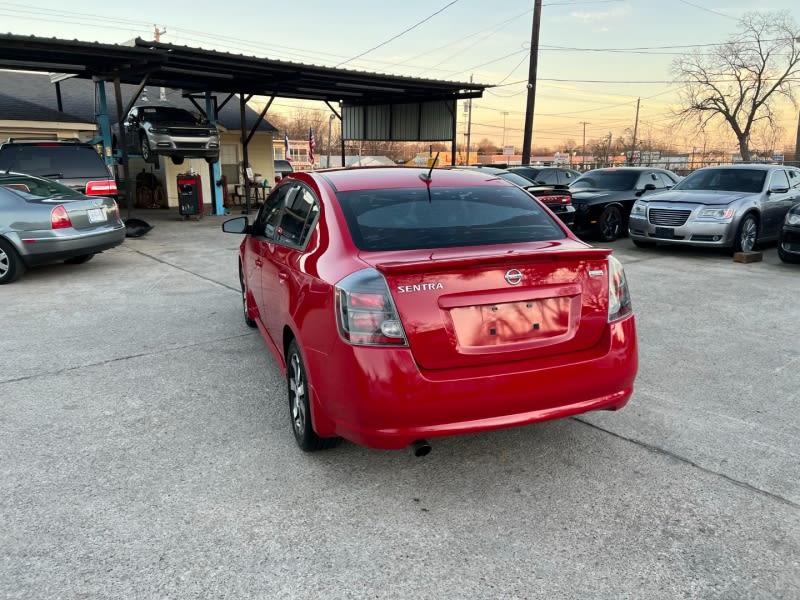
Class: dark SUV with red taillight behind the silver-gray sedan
0,138,117,198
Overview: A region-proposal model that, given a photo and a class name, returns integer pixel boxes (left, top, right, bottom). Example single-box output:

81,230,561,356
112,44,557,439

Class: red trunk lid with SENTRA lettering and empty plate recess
362,242,610,369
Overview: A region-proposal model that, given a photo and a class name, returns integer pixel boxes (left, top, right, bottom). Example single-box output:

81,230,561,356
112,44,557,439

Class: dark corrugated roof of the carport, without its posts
0,34,491,112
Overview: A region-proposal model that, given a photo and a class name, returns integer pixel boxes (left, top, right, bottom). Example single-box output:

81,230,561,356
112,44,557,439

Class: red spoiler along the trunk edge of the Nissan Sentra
375,248,611,275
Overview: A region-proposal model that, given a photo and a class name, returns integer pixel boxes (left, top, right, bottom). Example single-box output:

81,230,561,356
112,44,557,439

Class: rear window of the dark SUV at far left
0,144,111,179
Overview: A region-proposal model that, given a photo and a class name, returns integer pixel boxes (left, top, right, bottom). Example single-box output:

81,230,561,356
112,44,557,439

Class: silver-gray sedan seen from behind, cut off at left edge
0,171,125,284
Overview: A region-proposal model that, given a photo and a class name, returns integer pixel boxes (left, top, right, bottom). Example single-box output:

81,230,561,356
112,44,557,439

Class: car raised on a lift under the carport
112,104,219,165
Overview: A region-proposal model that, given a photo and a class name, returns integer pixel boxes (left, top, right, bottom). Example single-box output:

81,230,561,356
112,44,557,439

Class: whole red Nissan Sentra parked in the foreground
222,167,638,456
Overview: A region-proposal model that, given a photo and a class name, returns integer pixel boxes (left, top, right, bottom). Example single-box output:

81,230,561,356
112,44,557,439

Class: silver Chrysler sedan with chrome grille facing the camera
628,164,800,252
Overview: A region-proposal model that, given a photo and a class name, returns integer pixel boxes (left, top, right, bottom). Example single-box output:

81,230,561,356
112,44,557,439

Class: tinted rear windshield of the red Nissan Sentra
338,186,566,251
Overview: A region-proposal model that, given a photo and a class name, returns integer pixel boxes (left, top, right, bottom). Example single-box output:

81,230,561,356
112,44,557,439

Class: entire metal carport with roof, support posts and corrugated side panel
0,34,490,210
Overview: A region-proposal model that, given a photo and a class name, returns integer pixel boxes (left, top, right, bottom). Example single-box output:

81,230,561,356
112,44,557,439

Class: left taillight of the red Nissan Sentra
336,269,406,346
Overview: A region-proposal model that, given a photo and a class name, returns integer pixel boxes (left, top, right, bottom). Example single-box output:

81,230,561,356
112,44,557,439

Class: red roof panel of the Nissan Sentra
310,166,516,192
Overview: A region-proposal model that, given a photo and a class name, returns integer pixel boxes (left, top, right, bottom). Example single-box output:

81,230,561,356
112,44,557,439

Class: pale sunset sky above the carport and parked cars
0,0,800,151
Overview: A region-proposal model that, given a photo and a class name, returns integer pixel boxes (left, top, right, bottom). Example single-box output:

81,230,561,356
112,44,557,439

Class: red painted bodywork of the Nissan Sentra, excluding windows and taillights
240,169,638,448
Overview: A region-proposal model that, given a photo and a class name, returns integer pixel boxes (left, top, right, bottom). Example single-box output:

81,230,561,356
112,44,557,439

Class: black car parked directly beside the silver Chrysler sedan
569,167,680,242
